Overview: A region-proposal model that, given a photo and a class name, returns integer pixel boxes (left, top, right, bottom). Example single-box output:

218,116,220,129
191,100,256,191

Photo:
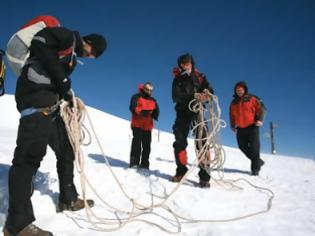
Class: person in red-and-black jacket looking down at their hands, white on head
129,82,160,169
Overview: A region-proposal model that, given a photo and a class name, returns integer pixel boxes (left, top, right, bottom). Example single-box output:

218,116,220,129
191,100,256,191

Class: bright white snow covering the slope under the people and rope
0,95,315,236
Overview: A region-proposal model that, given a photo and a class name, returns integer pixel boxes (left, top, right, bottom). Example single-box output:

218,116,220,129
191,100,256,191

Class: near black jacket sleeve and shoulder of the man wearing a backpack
30,27,74,97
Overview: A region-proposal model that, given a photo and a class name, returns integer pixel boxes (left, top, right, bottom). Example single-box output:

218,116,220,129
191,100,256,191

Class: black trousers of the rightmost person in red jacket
236,125,261,171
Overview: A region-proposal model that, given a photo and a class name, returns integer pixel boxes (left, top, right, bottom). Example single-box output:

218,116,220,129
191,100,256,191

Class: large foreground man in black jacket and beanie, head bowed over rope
3,27,106,236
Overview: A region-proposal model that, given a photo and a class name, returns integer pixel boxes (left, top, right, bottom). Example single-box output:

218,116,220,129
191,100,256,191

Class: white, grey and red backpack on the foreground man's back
6,15,60,77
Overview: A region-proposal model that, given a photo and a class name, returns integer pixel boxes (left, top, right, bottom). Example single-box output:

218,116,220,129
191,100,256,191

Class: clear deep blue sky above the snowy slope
0,0,315,158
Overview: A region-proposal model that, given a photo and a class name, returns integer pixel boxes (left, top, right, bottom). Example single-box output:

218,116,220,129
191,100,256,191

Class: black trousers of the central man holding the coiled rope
173,110,210,181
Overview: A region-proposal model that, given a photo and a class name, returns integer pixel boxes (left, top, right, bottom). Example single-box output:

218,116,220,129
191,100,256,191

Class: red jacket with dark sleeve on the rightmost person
230,94,264,128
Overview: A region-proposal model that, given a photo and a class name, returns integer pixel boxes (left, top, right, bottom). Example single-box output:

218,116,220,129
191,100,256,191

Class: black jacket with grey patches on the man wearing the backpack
15,27,83,111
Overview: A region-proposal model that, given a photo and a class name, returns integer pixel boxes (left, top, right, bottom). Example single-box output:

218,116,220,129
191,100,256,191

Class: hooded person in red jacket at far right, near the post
230,81,265,175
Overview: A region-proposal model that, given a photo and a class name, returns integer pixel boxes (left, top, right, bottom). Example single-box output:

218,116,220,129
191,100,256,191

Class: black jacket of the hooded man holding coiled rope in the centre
172,70,214,111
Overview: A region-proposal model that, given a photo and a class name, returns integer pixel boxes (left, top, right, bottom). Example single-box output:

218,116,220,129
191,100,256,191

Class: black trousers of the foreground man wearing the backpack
6,113,78,235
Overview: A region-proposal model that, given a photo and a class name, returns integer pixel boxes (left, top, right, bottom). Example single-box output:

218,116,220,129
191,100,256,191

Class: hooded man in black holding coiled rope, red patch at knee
171,54,213,188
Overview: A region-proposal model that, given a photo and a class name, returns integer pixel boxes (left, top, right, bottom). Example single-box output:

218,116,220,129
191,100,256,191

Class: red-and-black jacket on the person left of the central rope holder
129,85,159,131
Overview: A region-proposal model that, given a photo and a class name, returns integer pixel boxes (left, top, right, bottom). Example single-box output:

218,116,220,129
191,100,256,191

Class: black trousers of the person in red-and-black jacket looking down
129,128,151,169
